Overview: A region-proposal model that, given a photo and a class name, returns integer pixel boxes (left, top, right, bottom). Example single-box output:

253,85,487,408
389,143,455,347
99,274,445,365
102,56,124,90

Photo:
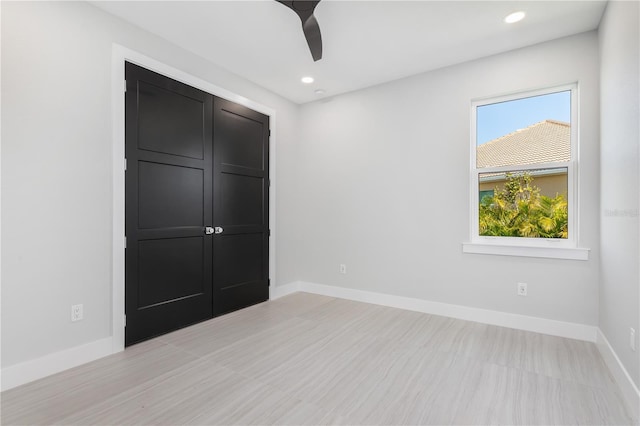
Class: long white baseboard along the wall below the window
292,281,597,342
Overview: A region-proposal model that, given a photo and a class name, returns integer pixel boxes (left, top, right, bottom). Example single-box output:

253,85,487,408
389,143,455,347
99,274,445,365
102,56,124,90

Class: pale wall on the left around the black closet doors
1,2,298,368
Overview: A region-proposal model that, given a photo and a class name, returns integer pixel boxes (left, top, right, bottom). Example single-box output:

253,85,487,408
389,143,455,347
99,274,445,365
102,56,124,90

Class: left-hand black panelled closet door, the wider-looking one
125,63,213,345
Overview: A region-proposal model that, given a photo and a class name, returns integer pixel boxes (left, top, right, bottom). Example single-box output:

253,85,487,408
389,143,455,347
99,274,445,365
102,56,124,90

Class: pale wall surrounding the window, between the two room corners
287,32,599,325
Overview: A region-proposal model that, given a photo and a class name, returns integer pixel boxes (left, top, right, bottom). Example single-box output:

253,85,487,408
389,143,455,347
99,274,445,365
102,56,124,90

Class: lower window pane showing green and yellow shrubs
478,167,568,238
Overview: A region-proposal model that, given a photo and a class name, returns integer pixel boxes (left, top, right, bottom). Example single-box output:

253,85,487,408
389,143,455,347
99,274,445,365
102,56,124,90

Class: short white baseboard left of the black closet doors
0,337,115,391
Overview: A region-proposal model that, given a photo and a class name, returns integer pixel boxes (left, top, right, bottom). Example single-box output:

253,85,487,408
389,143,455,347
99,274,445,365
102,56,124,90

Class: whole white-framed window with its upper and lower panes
464,85,582,258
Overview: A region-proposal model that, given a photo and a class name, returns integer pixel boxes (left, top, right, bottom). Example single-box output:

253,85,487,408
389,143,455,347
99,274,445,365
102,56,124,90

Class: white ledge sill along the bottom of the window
462,243,590,260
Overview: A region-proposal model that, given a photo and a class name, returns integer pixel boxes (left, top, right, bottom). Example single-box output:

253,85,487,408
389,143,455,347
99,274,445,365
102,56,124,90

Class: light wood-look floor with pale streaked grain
1,293,634,425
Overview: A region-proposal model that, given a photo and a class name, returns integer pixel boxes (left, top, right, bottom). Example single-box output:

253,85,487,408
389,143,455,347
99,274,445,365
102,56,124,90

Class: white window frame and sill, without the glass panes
463,83,589,260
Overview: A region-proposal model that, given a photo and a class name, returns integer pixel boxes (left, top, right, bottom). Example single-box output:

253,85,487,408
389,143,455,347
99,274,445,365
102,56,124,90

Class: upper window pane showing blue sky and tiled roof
476,90,571,168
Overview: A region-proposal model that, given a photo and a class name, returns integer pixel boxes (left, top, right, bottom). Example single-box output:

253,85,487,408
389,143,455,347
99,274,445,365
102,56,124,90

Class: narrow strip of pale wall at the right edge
599,1,640,387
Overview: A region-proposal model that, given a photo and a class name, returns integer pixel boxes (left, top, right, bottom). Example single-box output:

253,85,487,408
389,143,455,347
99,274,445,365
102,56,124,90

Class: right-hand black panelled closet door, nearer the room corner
213,98,269,315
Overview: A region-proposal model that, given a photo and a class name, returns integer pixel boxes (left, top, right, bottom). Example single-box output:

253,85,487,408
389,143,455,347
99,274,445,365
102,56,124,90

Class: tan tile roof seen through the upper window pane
476,120,571,168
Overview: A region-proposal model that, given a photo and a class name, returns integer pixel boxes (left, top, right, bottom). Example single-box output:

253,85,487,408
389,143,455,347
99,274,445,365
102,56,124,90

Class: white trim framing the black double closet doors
111,43,276,353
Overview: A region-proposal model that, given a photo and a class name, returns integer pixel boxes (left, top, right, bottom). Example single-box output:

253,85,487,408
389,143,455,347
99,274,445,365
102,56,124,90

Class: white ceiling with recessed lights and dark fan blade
92,0,606,103
